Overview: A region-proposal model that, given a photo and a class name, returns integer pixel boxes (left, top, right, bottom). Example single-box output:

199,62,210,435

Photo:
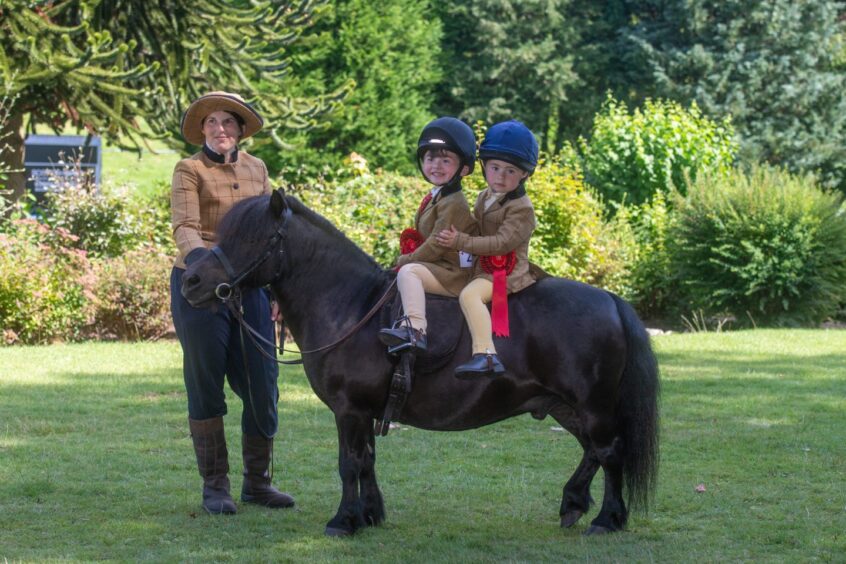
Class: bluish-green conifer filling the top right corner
626,0,846,189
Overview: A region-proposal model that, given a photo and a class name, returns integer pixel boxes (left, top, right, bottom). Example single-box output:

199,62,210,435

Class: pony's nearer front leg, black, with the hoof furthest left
326,411,381,537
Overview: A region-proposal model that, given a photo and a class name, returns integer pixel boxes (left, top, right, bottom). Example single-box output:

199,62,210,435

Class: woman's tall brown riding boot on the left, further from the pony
188,417,236,515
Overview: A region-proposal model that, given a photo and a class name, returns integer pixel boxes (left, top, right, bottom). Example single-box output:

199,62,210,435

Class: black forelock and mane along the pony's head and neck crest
217,195,382,270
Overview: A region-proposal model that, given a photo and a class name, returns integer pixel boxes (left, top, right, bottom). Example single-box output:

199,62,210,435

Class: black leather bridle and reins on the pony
211,207,397,364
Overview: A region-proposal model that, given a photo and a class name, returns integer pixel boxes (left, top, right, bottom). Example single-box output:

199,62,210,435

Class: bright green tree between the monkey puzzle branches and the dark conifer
268,0,441,184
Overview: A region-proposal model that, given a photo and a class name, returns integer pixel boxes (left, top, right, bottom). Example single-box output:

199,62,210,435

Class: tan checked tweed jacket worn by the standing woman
170,150,270,268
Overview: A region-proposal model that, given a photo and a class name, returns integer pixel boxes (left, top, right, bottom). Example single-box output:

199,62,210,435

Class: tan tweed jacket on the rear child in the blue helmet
455,188,537,293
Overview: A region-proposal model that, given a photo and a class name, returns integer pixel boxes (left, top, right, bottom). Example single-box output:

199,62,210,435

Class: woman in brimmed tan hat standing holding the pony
170,92,294,514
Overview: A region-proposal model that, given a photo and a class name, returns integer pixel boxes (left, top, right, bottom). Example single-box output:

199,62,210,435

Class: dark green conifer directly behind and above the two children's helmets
437,0,578,149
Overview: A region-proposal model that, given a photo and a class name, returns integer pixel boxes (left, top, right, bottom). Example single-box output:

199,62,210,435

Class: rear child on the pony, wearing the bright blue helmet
436,120,538,378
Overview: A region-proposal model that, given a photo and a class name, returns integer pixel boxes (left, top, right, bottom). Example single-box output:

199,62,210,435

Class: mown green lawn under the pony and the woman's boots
0,330,846,562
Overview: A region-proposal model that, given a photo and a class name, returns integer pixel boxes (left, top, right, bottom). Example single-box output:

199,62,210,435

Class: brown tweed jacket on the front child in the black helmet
397,190,476,296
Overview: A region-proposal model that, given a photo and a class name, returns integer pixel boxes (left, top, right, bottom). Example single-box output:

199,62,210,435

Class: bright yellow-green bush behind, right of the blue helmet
579,97,737,204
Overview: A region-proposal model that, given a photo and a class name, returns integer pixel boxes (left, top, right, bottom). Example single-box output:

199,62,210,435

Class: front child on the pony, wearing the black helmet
379,117,476,351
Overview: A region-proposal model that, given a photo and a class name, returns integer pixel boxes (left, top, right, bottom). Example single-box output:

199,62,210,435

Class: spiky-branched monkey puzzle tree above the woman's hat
0,0,350,200
